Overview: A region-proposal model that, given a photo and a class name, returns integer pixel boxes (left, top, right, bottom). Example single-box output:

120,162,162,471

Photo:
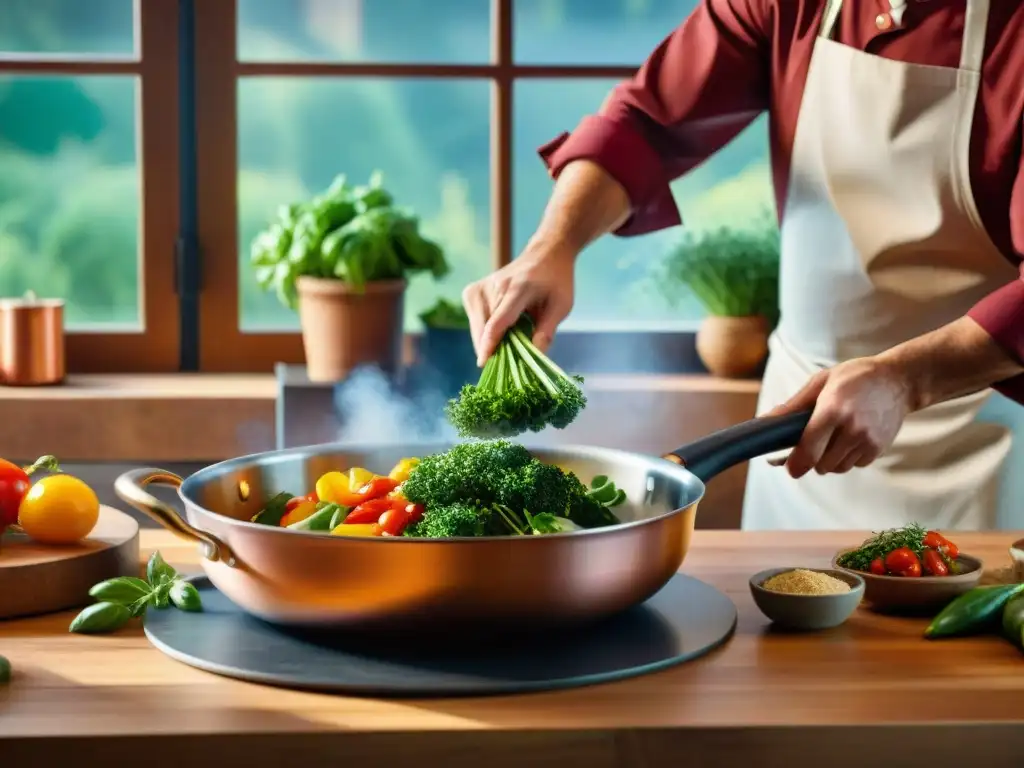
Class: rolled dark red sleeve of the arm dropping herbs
540,0,771,236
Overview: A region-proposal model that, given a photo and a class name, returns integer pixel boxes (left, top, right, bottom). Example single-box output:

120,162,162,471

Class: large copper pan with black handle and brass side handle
114,412,810,631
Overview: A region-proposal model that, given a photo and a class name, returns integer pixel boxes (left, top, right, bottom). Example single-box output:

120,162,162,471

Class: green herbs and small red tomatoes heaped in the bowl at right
837,523,959,578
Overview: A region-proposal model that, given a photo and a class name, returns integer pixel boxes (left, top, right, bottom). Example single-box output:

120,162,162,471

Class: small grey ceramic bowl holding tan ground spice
751,568,864,630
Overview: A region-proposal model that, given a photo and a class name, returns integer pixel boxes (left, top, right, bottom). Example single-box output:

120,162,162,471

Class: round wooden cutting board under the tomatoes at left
0,507,139,621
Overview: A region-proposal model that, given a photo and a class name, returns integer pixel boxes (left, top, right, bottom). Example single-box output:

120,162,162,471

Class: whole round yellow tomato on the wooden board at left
17,474,99,544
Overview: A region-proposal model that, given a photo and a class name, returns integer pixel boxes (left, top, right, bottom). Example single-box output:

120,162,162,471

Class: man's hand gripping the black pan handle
770,357,913,477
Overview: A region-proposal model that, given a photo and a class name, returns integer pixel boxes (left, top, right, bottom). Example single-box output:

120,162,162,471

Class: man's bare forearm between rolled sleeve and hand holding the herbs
532,160,630,254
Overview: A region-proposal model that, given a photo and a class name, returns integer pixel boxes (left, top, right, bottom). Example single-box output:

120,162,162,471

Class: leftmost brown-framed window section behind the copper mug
0,0,179,371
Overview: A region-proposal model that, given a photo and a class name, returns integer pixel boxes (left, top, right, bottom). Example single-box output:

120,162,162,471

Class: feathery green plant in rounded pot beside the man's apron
662,225,779,378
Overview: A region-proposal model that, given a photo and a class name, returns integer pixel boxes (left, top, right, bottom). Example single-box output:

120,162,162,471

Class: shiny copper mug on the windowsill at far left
0,295,66,387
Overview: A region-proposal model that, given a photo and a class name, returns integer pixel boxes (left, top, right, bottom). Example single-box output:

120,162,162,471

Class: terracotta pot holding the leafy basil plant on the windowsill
297,278,406,381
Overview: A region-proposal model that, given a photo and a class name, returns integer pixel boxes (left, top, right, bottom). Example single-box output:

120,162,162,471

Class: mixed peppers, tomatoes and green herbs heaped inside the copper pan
252,440,626,539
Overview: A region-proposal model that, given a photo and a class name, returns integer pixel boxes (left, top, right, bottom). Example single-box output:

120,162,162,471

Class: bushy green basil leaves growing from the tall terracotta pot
250,173,450,309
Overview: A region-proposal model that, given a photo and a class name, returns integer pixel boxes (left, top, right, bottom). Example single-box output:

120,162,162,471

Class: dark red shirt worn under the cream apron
541,0,1024,403
